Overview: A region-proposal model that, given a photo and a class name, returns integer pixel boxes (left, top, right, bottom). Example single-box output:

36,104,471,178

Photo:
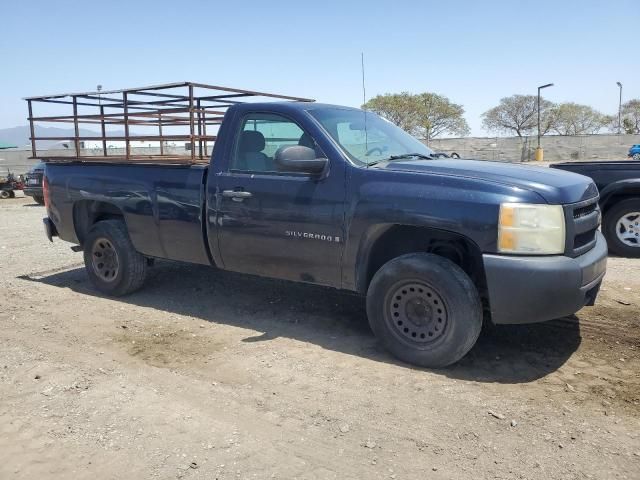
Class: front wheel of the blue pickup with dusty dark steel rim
367,253,482,368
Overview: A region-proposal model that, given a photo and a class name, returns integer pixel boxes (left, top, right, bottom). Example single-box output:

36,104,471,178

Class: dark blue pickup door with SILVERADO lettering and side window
216,112,345,286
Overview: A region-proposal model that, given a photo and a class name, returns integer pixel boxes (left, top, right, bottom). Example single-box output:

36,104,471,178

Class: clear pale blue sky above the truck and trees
0,0,640,136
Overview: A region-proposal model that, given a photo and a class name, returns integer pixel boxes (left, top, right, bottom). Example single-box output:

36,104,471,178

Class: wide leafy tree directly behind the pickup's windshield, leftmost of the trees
362,92,469,140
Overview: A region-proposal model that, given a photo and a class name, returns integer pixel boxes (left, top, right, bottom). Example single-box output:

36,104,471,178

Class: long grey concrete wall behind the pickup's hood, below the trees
429,135,640,162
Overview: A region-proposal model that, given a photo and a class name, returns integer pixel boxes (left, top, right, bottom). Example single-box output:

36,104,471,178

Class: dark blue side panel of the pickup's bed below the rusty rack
46,163,211,265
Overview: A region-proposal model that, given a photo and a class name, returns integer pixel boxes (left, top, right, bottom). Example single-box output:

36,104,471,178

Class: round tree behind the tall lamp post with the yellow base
482,95,555,137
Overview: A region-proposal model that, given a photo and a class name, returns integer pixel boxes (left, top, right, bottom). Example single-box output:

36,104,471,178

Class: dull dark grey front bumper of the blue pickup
483,232,607,324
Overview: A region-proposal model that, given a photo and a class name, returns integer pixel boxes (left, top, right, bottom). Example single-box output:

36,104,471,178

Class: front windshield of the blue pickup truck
309,108,433,165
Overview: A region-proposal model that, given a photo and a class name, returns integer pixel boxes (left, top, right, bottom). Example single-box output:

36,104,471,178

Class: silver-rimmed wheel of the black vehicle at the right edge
602,198,640,258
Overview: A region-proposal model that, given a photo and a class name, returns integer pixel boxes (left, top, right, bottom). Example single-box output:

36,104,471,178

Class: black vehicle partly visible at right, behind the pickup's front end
551,160,640,257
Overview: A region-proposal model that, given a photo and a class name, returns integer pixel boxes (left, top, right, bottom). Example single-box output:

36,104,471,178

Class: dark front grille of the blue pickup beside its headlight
565,197,600,257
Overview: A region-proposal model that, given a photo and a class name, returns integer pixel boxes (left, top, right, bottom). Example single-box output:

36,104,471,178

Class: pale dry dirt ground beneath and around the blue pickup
0,198,640,480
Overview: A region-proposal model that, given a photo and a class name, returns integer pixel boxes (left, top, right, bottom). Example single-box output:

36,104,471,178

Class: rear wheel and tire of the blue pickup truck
84,220,147,297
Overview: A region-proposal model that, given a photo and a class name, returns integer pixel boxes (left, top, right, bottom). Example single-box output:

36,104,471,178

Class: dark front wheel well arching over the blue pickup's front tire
358,225,488,311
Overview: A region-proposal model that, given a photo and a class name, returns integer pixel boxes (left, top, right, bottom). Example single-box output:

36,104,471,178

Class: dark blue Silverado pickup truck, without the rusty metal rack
37,92,607,367
